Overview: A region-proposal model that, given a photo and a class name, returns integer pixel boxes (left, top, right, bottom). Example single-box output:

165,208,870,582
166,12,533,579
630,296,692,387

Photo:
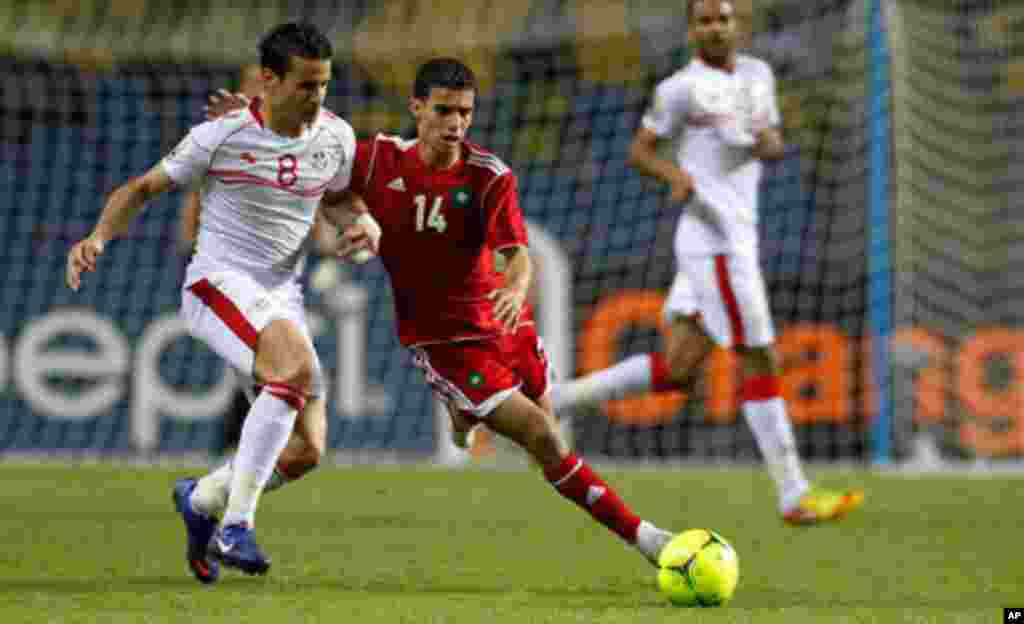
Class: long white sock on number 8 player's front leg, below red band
221,389,298,527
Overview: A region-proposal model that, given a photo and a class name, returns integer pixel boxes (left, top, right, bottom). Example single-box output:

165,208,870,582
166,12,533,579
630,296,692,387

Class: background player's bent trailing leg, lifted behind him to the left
551,271,715,410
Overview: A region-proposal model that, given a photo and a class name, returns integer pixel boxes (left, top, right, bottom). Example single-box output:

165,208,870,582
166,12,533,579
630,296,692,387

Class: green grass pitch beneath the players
0,464,1024,624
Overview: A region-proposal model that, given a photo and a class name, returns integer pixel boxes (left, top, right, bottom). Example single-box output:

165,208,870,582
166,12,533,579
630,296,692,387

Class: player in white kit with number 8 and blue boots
67,23,379,583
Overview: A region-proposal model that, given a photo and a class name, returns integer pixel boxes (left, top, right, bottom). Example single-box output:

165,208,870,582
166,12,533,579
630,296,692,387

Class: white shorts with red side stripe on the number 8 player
181,271,324,397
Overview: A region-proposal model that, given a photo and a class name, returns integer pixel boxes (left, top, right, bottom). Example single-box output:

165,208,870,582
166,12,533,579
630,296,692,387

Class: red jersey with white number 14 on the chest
350,134,529,346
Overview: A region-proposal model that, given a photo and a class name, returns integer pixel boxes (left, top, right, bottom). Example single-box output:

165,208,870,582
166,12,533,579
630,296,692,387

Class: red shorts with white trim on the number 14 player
412,325,553,418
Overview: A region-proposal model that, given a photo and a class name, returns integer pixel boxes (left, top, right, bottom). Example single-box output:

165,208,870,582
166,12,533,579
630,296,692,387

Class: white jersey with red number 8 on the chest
162,102,355,285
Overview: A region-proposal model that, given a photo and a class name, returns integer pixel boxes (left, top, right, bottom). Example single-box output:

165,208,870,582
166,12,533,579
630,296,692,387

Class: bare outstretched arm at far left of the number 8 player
65,165,172,291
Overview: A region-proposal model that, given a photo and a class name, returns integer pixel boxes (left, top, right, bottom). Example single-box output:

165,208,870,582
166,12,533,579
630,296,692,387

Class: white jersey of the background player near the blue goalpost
642,54,780,255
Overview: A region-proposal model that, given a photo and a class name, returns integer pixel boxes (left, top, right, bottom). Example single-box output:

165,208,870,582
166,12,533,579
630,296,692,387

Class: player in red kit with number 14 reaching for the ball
331,58,684,563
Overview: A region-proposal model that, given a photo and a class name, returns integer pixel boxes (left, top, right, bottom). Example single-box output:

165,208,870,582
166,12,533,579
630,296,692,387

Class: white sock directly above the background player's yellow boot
743,397,810,512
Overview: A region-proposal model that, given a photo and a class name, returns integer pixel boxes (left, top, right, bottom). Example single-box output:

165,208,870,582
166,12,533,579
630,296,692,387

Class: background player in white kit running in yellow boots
552,0,863,525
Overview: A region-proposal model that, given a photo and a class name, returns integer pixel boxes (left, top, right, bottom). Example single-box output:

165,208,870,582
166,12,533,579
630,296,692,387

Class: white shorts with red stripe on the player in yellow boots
662,254,775,348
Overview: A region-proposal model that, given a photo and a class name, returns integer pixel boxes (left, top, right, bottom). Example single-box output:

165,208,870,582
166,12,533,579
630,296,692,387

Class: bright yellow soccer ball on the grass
657,529,739,607
